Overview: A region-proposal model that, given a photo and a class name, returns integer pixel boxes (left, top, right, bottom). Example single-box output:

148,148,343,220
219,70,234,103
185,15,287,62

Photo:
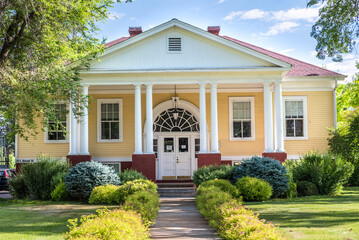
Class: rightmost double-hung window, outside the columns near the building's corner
283,96,308,140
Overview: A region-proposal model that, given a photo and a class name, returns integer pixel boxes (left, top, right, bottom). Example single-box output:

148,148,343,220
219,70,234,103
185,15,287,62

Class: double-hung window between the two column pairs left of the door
97,99,123,142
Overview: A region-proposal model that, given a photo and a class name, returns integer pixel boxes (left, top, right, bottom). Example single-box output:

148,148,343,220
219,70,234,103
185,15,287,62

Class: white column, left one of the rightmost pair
263,83,274,152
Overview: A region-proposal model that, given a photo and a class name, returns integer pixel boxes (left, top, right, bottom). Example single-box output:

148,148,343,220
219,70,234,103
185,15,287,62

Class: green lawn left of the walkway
0,199,114,240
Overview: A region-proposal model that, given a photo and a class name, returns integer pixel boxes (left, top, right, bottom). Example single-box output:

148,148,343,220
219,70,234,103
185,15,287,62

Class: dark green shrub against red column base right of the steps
193,165,234,187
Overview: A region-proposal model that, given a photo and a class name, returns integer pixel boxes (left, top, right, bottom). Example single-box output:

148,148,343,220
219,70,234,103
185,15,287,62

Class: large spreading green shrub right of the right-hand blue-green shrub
286,153,354,195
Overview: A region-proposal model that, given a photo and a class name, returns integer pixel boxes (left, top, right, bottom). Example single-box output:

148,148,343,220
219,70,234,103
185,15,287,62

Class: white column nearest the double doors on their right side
199,83,208,153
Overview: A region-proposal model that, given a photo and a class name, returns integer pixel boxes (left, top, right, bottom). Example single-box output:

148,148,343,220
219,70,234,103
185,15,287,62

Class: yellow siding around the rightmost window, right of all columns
283,91,334,155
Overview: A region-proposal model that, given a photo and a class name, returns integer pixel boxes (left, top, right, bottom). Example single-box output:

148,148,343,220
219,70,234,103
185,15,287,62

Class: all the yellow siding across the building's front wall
18,92,334,159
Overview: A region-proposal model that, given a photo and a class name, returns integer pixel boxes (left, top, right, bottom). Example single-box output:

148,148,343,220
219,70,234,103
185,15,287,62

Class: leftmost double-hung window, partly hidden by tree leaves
45,103,68,143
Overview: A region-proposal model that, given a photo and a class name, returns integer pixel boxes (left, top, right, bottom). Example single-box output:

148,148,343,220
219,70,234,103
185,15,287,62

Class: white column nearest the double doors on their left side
146,84,153,154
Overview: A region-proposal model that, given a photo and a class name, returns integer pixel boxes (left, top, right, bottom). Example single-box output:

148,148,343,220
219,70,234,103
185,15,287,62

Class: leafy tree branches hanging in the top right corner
307,0,359,61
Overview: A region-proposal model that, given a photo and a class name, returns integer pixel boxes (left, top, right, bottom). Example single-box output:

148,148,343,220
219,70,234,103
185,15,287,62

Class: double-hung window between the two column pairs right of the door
229,97,255,140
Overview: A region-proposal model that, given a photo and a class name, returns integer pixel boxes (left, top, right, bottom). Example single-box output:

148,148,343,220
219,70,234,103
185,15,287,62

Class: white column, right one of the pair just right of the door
211,84,219,153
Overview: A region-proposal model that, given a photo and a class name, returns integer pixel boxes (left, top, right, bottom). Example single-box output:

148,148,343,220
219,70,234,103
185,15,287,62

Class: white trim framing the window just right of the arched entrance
229,97,256,141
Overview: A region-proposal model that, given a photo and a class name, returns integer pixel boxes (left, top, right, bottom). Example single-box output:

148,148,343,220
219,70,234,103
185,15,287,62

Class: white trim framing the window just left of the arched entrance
97,98,123,143
